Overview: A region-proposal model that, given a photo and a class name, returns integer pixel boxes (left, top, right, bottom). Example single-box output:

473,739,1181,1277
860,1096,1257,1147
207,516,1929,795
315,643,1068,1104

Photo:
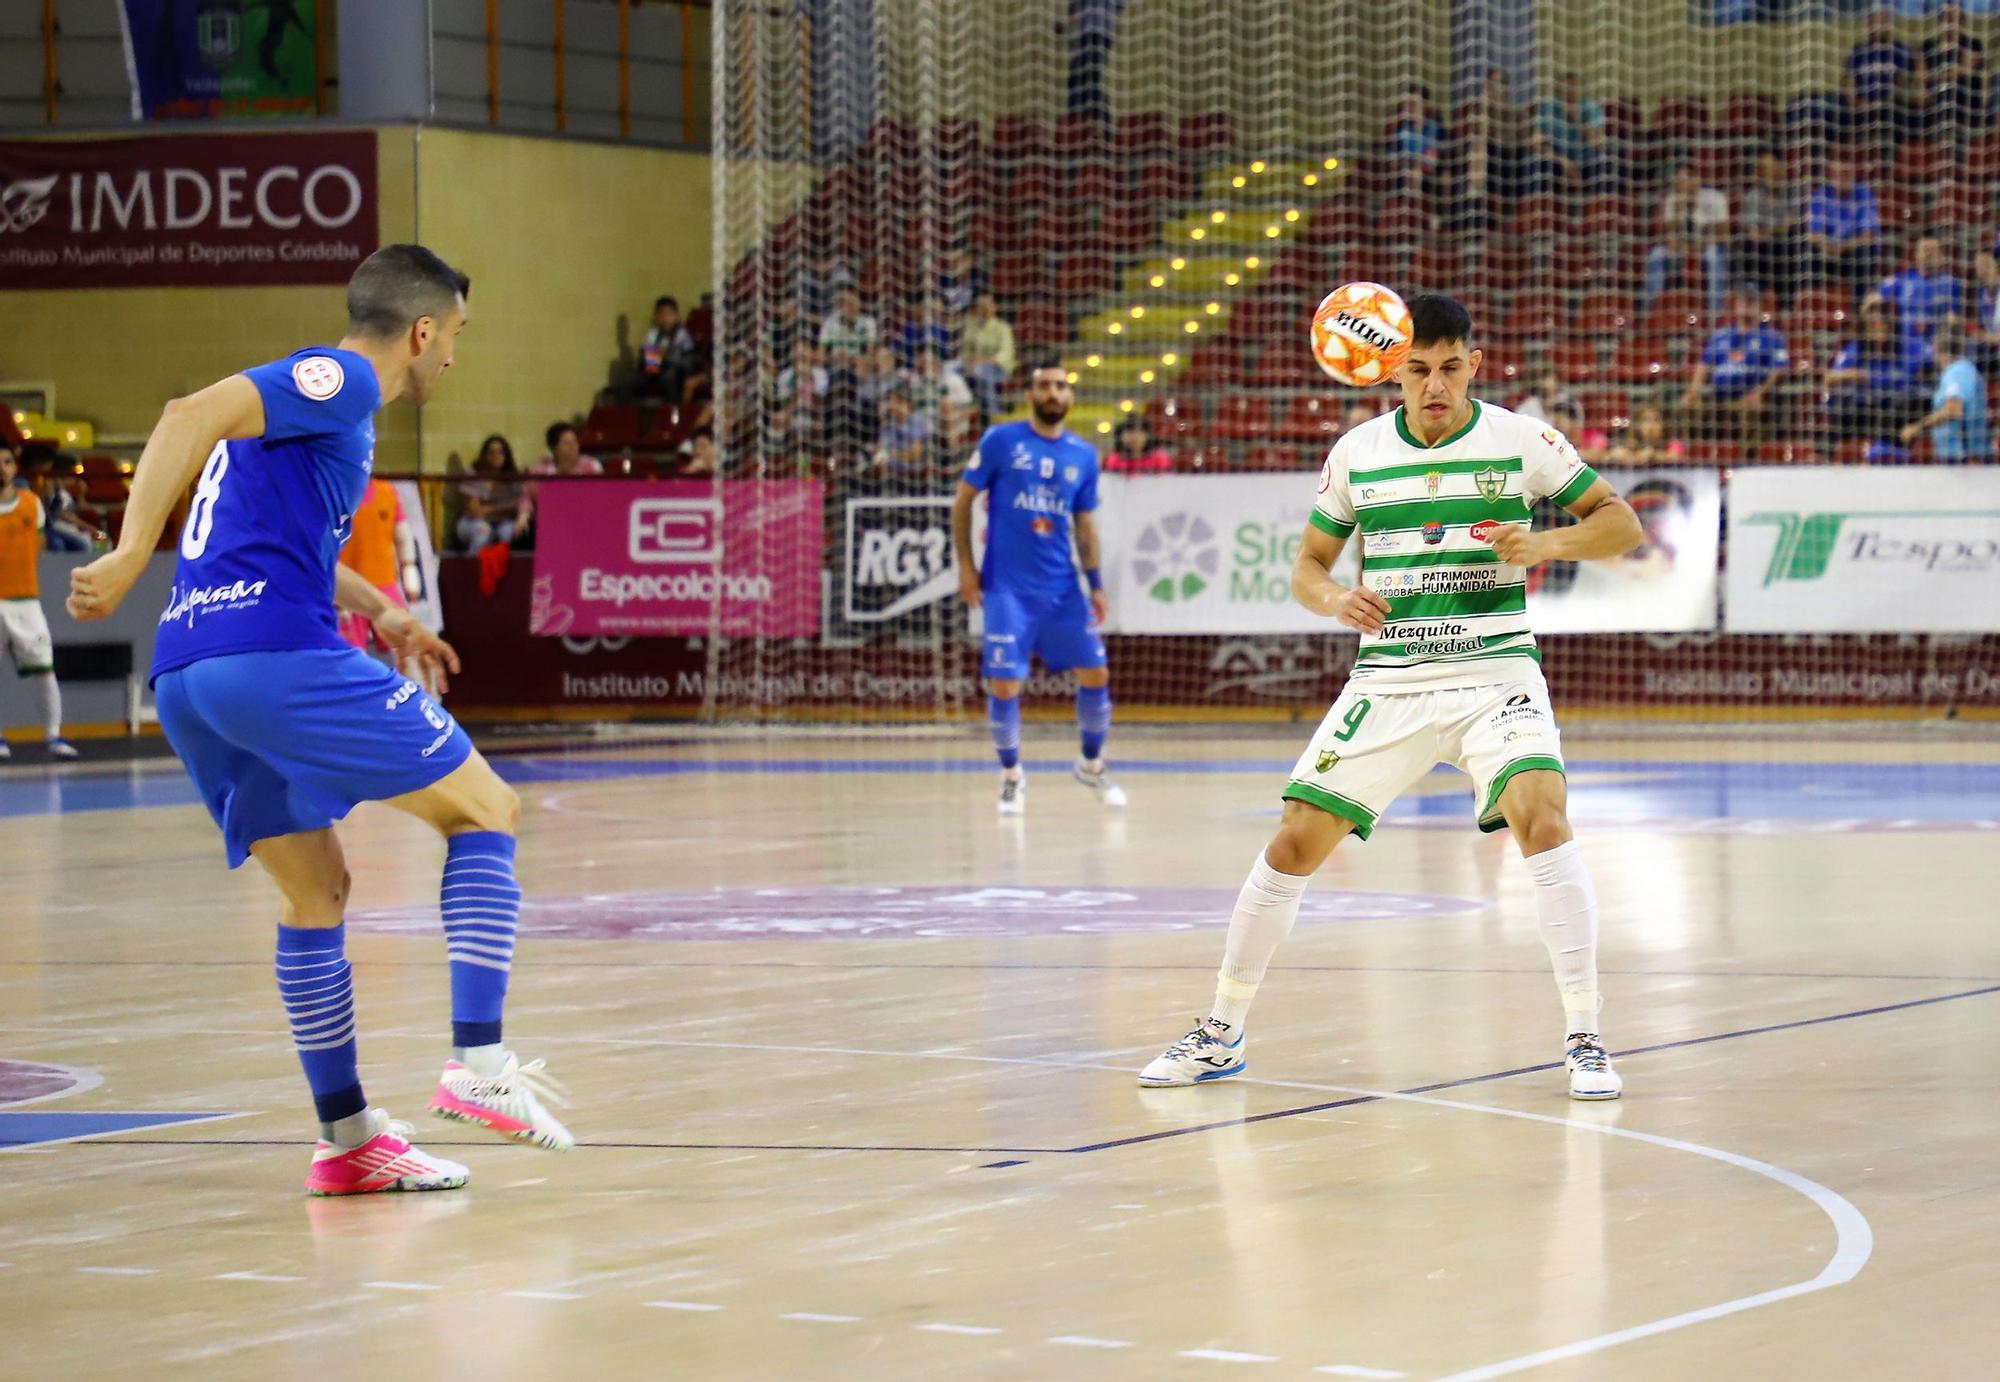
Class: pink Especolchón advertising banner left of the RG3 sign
528,480,826,638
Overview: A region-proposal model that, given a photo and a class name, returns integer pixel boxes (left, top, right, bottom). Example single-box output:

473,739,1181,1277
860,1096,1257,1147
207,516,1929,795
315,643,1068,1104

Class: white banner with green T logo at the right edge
1726,466,2000,634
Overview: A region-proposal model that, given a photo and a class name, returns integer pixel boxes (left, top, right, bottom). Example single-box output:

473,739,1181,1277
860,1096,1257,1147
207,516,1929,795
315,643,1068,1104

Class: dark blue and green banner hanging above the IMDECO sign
120,0,320,120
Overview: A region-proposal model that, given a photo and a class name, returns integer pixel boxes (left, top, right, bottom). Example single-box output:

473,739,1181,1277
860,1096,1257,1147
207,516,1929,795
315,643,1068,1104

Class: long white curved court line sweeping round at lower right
528,1038,1874,1382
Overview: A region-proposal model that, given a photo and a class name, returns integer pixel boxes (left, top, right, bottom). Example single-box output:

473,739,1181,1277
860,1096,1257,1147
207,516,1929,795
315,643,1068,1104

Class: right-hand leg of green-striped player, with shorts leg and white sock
1456,682,1622,1098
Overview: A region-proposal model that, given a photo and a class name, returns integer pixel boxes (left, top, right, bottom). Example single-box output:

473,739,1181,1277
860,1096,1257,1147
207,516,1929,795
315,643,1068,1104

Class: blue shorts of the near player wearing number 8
154,648,472,868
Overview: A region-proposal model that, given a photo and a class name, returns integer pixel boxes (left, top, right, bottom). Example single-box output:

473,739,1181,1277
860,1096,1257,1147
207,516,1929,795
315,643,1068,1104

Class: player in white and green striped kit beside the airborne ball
1140,294,1642,1098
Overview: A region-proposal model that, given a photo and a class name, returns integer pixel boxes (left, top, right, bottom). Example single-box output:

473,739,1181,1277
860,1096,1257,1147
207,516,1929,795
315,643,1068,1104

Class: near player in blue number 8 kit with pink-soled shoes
70,244,570,1194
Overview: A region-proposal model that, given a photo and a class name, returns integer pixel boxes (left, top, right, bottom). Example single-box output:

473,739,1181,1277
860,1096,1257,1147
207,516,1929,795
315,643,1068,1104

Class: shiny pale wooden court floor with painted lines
0,726,2000,1382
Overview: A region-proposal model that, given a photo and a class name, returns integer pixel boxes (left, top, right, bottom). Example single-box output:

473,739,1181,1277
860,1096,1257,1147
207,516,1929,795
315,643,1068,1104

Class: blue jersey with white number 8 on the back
152,346,382,678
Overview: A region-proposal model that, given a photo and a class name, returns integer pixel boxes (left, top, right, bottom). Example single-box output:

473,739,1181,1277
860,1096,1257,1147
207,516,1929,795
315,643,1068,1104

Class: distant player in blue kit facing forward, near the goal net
952,364,1126,816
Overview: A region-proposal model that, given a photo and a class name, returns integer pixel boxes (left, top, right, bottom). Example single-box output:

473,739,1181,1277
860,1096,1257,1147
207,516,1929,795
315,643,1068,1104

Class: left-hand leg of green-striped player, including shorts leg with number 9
1138,688,1438,1086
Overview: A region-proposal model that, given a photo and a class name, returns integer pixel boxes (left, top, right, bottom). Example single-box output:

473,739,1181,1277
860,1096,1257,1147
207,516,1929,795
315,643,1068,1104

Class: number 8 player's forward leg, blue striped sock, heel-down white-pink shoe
384,752,576,1152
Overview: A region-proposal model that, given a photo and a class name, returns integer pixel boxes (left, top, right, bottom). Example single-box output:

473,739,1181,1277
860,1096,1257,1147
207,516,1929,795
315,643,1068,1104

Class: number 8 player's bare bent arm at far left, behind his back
68,374,264,620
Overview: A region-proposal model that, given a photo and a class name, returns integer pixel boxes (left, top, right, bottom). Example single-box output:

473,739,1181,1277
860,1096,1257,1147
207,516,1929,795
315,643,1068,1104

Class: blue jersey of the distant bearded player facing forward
966,422,1098,600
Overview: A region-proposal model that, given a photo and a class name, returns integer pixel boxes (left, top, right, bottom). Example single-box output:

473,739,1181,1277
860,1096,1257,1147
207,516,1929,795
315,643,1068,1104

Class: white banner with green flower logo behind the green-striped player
1098,470,1722,634
